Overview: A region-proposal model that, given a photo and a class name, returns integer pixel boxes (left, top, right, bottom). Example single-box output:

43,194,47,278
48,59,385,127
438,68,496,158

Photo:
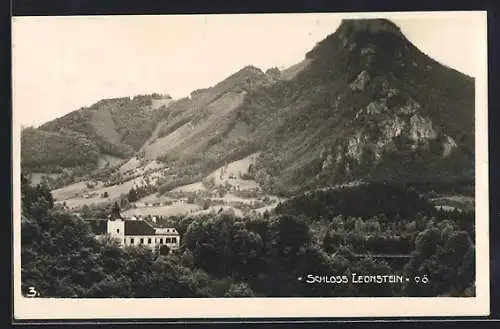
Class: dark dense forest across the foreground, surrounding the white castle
21,177,475,297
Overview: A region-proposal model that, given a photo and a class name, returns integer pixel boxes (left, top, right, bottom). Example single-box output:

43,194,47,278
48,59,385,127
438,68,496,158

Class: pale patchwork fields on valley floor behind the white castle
53,153,282,216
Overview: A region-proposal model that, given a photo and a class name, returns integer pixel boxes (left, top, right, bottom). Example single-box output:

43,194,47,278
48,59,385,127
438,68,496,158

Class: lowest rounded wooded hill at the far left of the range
21,94,171,172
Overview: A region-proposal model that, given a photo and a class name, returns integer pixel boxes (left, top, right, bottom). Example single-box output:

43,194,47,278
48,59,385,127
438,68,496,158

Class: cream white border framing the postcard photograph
13,11,490,320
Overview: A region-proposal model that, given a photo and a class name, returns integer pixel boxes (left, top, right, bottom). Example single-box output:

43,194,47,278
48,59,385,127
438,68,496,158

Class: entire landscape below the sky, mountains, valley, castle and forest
21,19,476,298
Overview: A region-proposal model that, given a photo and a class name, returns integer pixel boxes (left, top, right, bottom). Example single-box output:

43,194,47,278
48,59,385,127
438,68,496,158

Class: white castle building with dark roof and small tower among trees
87,216,180,251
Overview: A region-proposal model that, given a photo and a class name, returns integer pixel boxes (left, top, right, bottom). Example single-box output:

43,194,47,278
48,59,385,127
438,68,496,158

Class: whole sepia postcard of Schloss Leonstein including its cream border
12,12,489,318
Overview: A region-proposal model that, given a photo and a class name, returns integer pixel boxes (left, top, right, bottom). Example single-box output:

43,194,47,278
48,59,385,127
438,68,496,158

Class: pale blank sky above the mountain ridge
12,12,486,126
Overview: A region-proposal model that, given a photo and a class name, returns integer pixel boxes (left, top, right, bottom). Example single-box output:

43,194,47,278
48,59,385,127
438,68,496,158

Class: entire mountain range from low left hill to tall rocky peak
22,19,475,199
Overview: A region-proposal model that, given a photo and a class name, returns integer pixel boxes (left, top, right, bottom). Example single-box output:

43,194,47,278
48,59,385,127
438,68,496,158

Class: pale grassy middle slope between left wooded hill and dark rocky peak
143,66,275,161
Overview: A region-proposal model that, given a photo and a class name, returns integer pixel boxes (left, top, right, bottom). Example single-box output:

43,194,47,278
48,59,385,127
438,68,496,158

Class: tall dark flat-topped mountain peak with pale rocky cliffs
232,19,474,189
